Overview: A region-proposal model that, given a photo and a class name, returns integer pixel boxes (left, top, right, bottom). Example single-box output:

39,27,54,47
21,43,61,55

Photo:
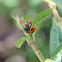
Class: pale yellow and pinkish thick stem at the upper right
43,0,61,21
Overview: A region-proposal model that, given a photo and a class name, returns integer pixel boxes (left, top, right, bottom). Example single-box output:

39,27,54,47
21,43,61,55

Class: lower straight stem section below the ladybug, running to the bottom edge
30,42,45,62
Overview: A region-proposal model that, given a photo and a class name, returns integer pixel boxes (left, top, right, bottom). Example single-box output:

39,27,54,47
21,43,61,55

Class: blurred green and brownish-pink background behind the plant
0,0,62,62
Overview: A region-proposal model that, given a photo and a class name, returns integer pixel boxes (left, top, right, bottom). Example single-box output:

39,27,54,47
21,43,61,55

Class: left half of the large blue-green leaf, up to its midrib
50,25,59,57
